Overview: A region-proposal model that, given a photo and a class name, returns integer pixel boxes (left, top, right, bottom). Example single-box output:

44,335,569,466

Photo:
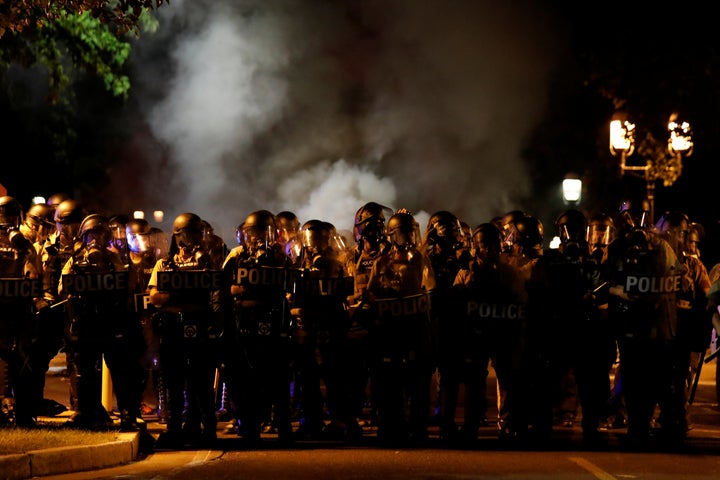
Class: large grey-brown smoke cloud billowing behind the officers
133,0,558,245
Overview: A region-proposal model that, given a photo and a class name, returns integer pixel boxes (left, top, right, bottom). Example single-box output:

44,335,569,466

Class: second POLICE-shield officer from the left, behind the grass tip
58,214,142,431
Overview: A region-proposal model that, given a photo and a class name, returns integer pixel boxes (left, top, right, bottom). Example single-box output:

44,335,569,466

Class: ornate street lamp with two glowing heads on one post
610,113,693,222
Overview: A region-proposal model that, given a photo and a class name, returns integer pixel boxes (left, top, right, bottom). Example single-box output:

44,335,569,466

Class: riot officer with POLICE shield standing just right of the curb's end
148,212,224,448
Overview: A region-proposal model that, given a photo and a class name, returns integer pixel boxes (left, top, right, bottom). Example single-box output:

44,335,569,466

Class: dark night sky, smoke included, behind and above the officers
0,0,720,262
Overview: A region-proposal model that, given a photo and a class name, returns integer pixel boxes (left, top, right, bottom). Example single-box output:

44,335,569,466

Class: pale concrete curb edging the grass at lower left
0,432,140,480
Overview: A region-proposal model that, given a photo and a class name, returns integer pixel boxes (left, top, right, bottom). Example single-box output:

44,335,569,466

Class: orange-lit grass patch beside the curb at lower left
0,423,119,455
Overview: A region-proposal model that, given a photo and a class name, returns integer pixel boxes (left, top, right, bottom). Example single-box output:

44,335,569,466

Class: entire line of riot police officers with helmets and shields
0,196,717,448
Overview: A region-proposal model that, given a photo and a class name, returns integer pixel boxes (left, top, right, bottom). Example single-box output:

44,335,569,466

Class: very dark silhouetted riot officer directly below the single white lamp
528,209,615,447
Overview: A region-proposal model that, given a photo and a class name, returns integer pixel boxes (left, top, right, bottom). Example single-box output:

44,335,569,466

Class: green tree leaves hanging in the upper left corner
0,0,167,102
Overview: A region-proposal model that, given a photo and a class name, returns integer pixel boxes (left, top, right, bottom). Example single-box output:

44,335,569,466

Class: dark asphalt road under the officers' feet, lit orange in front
36,350,720,480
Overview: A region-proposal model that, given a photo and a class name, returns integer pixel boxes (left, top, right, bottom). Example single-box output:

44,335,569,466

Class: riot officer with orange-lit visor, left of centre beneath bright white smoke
292,219,362,441
